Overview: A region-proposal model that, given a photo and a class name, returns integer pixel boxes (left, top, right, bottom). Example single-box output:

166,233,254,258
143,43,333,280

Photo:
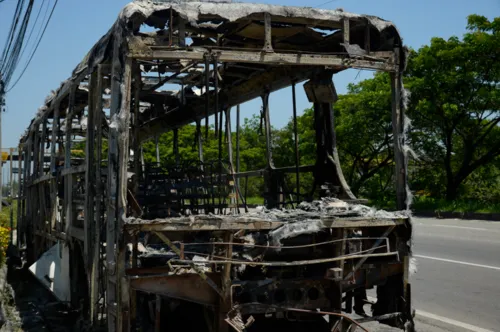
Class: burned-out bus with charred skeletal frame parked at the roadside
17,1,413,331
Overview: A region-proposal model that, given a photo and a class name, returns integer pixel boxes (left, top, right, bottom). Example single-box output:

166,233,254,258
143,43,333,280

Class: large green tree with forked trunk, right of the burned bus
408,15,500,200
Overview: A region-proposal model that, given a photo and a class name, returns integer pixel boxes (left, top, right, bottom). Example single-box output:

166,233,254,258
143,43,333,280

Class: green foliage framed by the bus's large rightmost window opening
334,73,394,197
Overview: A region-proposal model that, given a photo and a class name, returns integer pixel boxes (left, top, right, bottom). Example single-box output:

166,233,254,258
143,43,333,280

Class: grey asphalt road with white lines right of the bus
412,218,500,331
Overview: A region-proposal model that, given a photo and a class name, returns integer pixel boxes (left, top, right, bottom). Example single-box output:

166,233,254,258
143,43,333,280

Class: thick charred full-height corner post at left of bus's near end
106,40,132,332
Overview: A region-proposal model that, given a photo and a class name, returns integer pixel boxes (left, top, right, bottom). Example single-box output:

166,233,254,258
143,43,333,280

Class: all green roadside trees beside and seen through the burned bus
138,15,500,212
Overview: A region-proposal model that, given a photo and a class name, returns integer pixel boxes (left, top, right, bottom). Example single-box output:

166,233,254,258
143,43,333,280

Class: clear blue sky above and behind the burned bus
0,0,500,148
